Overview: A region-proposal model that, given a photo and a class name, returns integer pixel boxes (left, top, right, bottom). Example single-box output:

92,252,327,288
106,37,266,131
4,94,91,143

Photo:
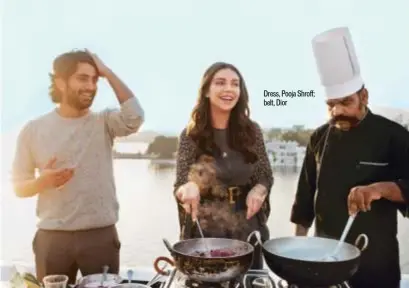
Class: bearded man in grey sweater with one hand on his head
13,51,144,283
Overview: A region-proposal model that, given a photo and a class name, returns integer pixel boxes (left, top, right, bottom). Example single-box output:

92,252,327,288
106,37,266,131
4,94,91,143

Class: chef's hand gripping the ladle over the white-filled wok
348,185,382,215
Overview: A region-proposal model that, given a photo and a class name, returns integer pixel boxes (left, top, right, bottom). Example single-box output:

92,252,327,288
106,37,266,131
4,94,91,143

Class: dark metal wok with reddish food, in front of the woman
154,231,258,283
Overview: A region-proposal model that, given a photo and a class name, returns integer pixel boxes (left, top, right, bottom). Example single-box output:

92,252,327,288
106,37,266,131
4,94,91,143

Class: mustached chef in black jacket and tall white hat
291,27,409,288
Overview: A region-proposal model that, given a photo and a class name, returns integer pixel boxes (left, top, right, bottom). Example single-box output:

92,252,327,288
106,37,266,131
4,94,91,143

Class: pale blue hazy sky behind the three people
1,0,409,133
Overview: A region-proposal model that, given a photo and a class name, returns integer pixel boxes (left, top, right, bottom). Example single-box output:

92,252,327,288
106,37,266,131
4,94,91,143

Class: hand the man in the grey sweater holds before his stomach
37,157,74,190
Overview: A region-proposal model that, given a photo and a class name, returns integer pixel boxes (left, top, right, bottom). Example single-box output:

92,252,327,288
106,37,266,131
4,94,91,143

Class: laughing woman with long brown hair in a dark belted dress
174,62,273,269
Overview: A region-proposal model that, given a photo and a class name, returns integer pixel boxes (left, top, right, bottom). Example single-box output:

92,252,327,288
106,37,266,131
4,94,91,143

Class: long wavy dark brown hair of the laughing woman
187,62,257,163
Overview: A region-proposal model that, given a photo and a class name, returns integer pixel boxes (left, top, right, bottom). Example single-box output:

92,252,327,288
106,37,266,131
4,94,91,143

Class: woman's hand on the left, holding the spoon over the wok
176,182,200,221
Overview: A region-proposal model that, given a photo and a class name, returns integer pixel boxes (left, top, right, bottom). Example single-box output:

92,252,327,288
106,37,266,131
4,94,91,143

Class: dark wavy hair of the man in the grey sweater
49,50,97,103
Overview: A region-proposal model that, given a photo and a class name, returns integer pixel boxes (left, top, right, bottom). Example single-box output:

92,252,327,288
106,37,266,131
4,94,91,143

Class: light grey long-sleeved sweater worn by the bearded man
12,97,144,231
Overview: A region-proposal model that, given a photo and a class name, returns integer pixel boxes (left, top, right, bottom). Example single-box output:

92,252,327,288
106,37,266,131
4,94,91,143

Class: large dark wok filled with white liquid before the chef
263,234,368,287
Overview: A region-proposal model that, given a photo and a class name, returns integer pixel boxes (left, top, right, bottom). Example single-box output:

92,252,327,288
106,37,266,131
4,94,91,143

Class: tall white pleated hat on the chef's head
312,27,364,99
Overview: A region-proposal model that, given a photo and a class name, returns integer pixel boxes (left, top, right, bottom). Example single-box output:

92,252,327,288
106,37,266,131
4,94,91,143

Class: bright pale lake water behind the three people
0,142,409,273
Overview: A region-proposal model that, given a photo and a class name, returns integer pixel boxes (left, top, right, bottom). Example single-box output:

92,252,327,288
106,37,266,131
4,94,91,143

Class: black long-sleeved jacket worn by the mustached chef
291,111,409,288
